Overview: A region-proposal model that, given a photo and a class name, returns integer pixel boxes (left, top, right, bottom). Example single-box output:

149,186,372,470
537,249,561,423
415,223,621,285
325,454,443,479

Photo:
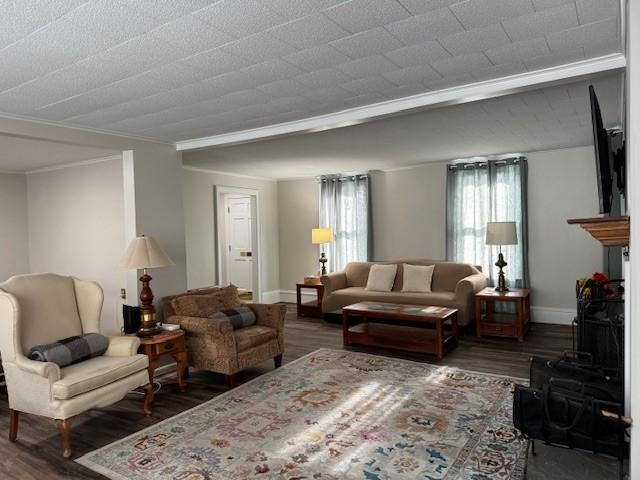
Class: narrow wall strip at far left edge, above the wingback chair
0,174,29,282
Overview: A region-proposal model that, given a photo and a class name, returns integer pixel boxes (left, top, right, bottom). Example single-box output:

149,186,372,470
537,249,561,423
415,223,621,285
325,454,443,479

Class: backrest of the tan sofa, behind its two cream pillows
344,260,480,292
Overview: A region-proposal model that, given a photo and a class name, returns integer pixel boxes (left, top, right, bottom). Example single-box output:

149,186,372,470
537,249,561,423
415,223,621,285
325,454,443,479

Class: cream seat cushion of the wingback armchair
52,355,149,400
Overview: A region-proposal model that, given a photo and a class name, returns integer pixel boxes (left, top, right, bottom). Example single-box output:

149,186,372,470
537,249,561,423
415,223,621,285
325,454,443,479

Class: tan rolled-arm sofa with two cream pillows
321,260,487,325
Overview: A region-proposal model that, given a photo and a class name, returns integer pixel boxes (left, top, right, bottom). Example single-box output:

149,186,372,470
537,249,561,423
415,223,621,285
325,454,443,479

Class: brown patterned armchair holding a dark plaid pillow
162,285,286,388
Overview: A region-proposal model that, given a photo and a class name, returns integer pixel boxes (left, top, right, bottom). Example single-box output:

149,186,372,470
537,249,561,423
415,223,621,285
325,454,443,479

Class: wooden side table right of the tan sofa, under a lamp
476,287,531,342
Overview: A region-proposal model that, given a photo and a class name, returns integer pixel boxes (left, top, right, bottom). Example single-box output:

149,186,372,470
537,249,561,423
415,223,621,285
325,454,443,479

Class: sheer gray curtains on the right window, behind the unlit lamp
447,157,529,288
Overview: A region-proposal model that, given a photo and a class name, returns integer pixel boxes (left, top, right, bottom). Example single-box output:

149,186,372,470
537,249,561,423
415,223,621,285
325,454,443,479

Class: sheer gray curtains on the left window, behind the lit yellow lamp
319,174,372,272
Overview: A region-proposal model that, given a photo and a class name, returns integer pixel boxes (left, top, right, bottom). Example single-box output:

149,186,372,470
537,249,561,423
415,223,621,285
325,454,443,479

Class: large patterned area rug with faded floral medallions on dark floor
77,349,526,480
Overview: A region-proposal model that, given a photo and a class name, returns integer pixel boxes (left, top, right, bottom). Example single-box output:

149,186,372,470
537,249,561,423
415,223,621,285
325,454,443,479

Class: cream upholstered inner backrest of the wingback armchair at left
0,273,83,353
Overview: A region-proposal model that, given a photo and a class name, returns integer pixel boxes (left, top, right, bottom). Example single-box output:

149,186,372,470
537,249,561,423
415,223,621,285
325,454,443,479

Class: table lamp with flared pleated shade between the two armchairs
118,235,175,337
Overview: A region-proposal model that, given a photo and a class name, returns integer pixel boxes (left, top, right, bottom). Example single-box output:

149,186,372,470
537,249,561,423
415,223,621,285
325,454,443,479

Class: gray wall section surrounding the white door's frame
183,169,280,293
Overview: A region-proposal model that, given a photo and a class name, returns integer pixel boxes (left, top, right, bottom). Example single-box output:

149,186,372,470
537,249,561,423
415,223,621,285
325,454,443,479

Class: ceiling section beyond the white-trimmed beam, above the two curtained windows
183,75,622,179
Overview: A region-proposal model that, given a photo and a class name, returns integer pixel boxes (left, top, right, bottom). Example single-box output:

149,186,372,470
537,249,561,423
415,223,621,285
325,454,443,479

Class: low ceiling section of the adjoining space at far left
0,135,122,172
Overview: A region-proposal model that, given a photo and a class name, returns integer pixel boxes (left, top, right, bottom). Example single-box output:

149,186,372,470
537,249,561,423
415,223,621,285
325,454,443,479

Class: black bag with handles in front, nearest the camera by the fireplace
513,378,627,458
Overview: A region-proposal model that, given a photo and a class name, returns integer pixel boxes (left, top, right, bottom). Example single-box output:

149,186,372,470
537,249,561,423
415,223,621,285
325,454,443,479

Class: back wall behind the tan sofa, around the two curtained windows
279,146,602,322
